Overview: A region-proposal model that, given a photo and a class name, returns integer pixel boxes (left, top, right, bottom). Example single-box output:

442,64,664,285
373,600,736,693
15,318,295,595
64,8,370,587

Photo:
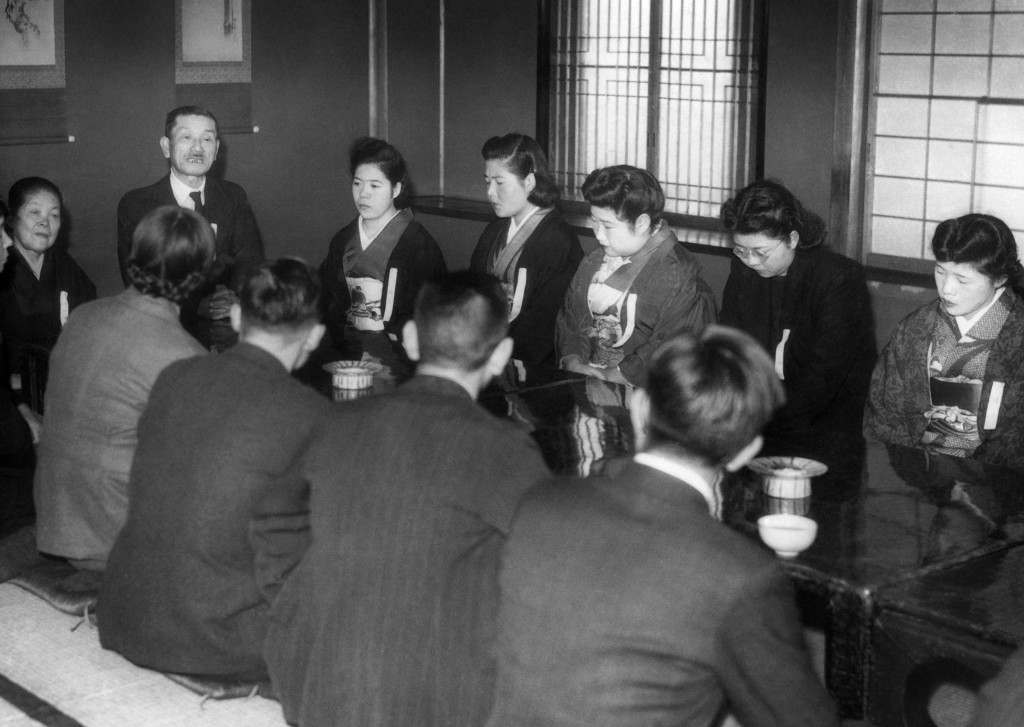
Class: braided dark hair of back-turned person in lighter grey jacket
127,205,215,303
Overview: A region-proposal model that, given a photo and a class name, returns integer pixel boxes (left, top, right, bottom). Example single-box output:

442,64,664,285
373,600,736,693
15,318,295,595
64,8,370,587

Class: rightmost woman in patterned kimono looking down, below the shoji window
864,214,1024,469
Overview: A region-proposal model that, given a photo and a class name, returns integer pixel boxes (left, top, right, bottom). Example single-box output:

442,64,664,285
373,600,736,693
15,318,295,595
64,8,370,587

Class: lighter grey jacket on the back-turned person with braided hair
35,288,205,561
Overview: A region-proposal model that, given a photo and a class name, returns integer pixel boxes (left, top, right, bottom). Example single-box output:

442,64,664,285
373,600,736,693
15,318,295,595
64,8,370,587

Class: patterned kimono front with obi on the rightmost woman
926,296,1010,457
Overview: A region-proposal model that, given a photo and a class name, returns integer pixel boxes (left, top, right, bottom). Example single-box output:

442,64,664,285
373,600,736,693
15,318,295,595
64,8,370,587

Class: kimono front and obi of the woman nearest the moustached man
341,209,413,331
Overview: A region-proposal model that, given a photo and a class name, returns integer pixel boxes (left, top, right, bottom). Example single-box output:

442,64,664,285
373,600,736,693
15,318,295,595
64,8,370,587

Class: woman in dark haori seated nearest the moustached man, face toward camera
321,138,445,367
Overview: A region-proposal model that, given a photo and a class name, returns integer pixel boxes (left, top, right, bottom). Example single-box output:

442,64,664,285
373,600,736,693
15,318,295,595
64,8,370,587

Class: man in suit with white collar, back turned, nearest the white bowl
487,327,839,727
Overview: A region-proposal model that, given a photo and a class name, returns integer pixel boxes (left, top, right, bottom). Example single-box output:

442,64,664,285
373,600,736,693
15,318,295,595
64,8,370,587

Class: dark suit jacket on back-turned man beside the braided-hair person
97,343,330,678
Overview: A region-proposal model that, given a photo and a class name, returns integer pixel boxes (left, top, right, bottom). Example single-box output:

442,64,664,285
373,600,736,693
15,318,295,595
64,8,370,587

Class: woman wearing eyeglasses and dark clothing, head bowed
720,179,876,469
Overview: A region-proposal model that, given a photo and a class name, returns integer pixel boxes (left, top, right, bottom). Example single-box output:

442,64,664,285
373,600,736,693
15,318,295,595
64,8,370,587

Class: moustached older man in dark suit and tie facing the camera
118,105,263,320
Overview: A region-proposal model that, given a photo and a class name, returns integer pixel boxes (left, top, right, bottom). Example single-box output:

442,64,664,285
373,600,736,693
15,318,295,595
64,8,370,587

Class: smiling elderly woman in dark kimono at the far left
0,177,96,393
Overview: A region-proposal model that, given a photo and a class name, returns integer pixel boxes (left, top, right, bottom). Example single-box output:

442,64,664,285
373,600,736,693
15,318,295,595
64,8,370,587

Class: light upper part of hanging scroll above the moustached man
174,0,253,85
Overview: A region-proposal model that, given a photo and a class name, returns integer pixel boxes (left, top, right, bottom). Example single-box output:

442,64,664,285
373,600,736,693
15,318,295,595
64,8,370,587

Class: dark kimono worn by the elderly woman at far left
0,246,96,387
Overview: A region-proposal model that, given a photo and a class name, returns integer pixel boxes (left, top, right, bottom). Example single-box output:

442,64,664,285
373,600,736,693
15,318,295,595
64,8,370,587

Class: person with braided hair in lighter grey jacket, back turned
35,206,215,570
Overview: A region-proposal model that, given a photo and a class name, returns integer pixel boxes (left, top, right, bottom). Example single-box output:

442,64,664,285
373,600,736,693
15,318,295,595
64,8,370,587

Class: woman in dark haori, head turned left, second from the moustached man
469,133,583,368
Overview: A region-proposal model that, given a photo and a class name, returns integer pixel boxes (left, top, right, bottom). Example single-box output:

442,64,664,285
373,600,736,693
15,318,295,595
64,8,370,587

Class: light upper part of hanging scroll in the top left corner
0,0,65,89
